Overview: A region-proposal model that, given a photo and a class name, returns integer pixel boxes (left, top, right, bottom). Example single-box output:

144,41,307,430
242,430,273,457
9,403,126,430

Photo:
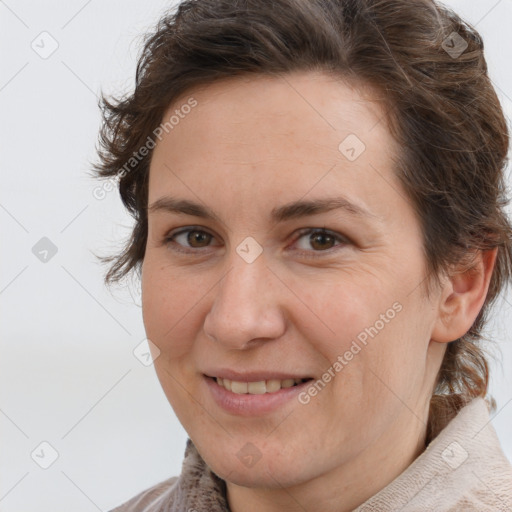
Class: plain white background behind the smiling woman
0,0,512,512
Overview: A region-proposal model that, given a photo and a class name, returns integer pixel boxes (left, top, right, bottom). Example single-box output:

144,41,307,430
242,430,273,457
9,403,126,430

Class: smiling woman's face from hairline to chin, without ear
142,73,444,488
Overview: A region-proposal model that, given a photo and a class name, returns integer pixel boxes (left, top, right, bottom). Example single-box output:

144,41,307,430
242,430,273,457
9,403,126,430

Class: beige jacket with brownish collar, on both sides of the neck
111,398,512,512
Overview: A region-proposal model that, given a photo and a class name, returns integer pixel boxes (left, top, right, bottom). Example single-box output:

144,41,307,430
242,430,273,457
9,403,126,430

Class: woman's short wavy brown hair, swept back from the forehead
91,0,512,442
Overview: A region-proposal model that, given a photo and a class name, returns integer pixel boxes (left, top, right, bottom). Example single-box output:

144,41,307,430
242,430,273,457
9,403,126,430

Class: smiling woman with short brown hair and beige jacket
92,0,512,512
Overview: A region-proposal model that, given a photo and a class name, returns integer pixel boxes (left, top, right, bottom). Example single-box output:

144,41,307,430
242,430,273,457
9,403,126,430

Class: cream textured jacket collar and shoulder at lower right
355,398,512,512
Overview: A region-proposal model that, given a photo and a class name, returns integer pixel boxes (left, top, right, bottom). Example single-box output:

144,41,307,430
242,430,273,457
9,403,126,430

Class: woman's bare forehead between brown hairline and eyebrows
146,72,402,216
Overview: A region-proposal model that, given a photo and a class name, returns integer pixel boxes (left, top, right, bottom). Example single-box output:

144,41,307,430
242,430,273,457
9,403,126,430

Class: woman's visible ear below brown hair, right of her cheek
431,248,498,343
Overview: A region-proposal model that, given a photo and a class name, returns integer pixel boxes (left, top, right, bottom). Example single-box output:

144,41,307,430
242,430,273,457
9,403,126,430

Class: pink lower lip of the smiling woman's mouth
203,375,312,416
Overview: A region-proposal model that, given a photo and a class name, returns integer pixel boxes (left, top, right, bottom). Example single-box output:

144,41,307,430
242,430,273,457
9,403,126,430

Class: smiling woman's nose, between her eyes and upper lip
204,251,286,350
